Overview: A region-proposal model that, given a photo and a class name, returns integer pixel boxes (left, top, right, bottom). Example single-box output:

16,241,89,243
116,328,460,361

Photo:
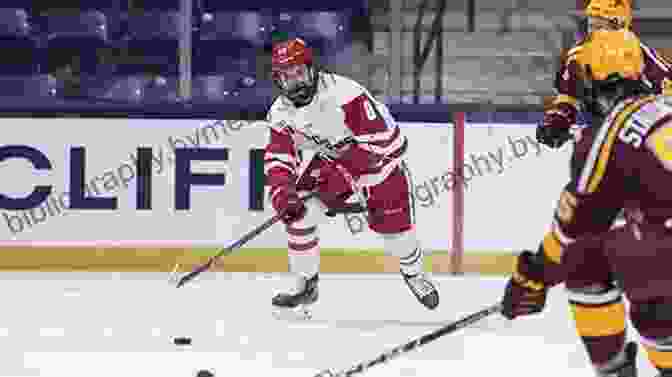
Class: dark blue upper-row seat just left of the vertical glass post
118,12,180,75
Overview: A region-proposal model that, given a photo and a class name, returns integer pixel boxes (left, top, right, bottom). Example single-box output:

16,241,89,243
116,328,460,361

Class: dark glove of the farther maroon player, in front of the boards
537,103,576,148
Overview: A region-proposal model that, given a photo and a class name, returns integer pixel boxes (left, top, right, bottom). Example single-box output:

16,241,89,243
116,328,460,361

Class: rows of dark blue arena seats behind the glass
0,0,365,105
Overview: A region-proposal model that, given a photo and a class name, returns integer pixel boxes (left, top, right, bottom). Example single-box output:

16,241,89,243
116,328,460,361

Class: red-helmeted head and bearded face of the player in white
271,38,317,106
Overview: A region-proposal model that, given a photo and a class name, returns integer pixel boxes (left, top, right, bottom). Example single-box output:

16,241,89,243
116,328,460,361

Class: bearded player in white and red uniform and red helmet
264,39,439,316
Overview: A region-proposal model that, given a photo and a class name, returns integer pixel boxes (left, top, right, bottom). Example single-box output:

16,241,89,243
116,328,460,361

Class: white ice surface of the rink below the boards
0,273,655,377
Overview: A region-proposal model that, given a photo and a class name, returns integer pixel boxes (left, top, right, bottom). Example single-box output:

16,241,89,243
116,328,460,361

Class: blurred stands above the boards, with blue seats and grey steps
0,0,672,114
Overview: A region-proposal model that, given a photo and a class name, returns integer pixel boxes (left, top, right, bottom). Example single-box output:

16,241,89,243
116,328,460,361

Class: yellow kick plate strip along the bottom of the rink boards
0,248,515,275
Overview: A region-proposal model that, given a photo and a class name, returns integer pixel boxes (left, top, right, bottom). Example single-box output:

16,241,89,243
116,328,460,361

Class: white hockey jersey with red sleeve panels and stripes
264,72,407,186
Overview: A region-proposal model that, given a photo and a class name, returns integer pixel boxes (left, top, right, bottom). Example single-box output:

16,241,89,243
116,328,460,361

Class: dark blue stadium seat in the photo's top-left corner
0,9,39,75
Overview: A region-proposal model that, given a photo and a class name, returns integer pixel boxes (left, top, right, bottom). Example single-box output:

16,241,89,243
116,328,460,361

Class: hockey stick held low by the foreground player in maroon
315,303,502,377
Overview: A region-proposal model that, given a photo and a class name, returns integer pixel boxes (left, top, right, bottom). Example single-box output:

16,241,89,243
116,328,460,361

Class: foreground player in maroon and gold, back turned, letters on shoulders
503,29,672,377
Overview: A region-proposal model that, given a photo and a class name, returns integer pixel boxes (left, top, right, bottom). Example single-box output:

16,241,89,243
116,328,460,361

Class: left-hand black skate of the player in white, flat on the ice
272,274,319,319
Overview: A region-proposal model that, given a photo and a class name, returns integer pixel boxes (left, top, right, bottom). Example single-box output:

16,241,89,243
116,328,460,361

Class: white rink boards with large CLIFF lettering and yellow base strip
0,119,569,272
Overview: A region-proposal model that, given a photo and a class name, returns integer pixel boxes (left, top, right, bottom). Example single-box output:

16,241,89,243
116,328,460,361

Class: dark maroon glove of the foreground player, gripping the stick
502,250,548,319
